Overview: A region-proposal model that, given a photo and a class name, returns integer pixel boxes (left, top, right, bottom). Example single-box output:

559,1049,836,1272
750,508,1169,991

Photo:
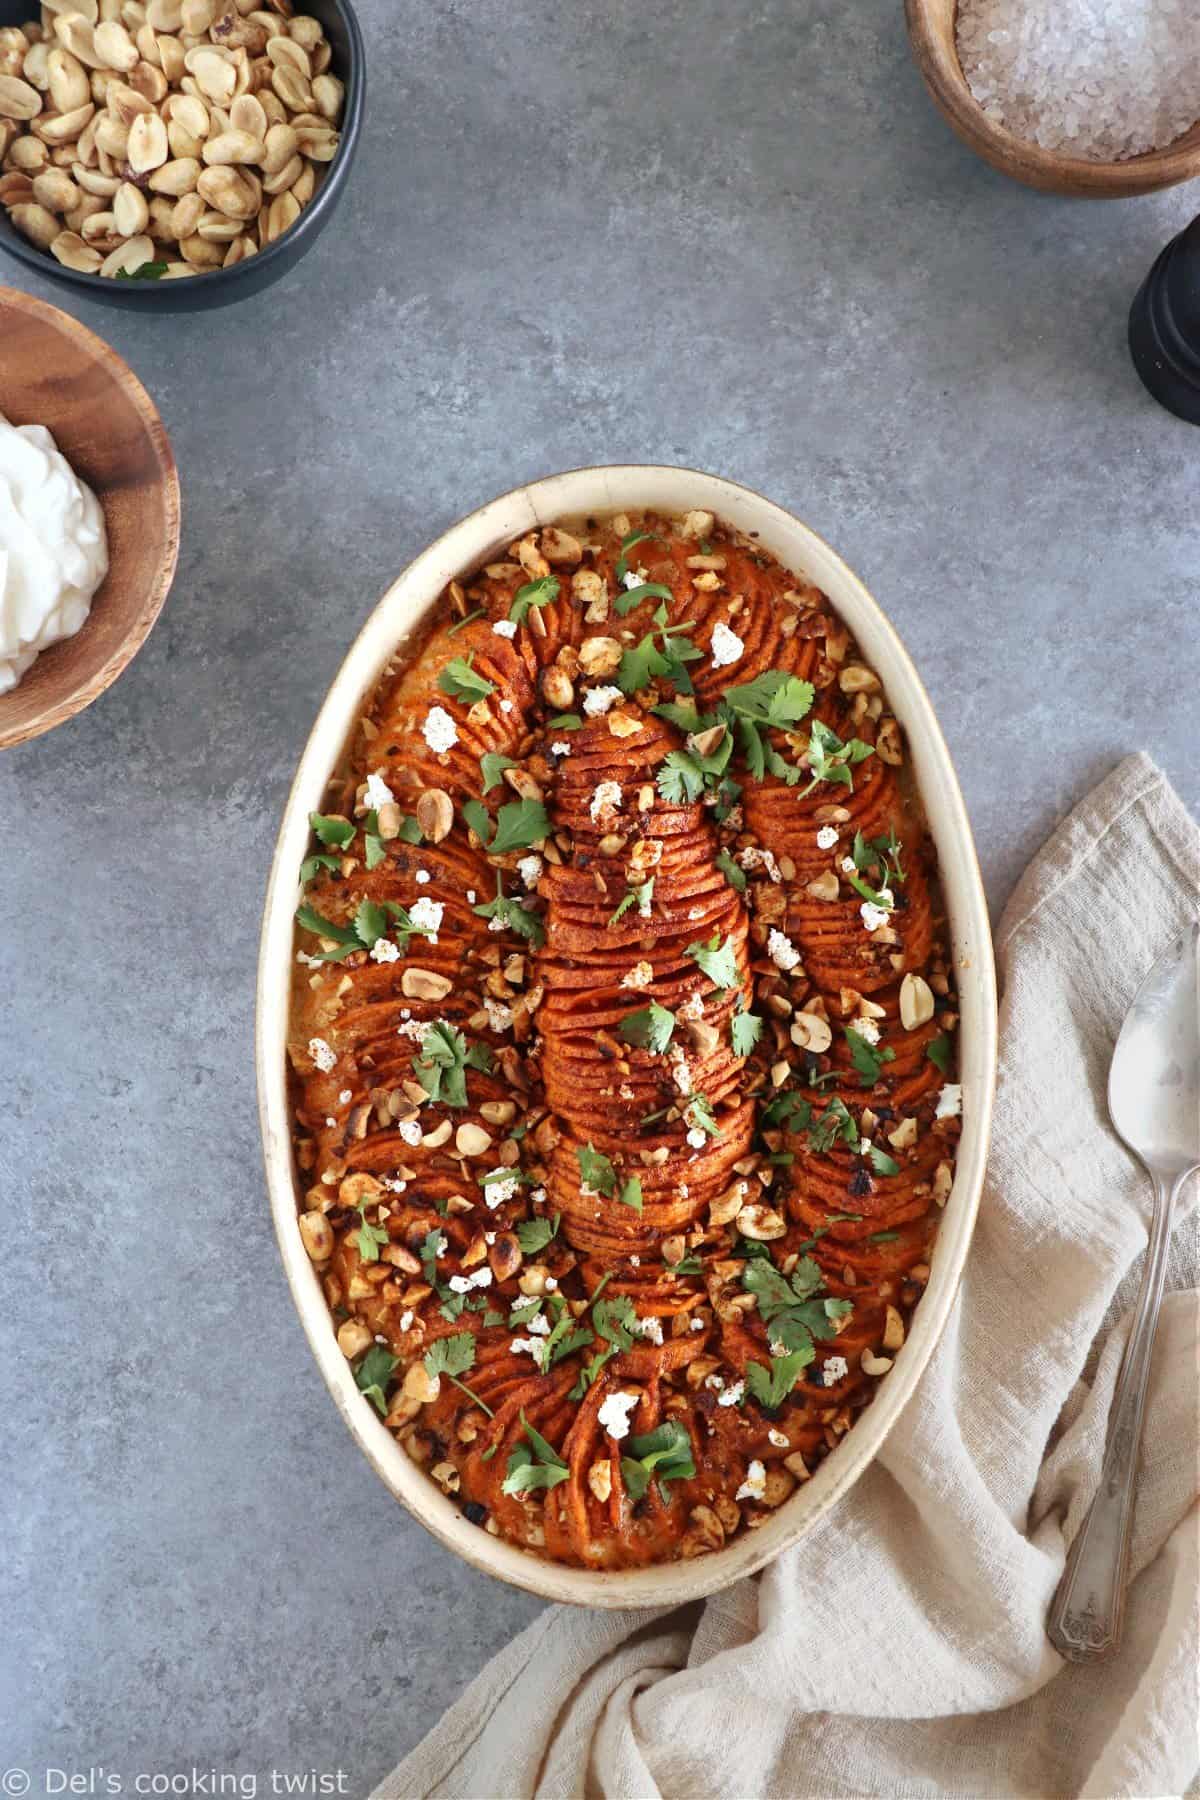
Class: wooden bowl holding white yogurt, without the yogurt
0,288,180,749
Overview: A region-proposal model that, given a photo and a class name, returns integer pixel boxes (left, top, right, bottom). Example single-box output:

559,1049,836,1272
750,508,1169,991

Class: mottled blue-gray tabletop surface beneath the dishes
0,0,1200,1793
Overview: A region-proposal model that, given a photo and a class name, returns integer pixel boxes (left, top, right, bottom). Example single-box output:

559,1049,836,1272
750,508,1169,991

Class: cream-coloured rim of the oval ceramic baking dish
255,464,997,1607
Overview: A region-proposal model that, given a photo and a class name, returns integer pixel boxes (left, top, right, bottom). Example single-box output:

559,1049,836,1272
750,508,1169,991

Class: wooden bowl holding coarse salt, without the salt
905,0,1200,200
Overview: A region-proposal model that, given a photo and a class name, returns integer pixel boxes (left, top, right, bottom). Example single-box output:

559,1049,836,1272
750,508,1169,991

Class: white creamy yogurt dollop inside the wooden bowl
0,414,108,693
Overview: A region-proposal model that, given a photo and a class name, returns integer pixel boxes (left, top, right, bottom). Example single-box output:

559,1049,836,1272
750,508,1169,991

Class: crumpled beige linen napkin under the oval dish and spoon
376,756,1200,1800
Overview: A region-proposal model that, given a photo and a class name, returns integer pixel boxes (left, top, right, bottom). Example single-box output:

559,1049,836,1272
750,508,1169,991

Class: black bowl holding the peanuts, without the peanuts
0,0,367,313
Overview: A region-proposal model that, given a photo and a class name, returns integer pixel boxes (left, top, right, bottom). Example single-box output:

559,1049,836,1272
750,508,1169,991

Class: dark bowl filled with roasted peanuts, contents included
0,0,365,311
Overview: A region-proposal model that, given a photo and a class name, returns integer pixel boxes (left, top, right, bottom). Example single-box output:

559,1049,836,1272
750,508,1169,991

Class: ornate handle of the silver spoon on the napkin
1045,1175,1186,1663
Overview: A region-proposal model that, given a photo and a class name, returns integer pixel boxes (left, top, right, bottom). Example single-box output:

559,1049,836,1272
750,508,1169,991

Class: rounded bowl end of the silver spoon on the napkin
1108,925,1200,1179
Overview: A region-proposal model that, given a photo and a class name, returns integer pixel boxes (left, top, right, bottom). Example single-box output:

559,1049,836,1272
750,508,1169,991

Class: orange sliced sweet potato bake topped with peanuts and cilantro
290,513,959,1568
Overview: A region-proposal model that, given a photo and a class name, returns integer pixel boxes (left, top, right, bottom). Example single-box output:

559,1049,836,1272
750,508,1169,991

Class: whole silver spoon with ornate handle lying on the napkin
1045,925,1200,1663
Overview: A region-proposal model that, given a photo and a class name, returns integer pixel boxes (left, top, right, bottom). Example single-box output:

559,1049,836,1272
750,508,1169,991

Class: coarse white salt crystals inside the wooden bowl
957,0,1200,162
